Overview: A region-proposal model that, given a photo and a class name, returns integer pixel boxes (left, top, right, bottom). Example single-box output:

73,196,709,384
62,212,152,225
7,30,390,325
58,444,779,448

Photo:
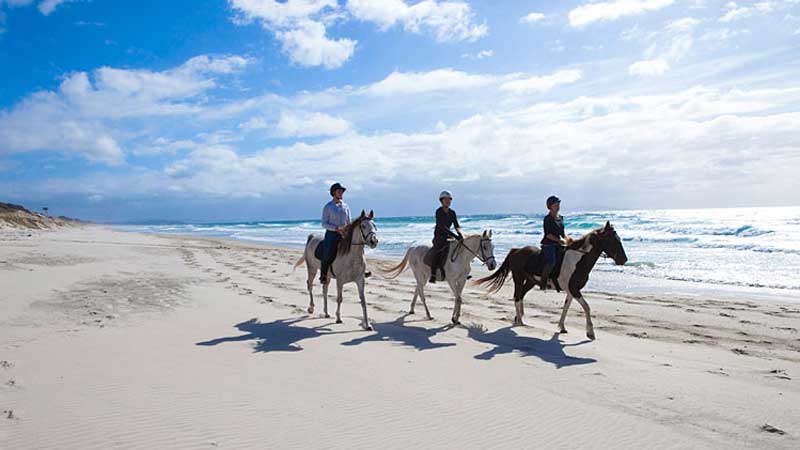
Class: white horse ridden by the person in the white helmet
382,230,497,324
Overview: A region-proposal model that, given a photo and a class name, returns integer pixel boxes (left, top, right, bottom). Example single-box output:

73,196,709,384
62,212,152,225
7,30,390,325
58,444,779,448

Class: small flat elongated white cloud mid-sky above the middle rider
364,69,493,96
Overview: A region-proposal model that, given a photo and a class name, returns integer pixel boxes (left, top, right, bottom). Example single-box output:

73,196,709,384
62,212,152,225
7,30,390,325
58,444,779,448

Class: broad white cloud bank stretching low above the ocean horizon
37,88,800,207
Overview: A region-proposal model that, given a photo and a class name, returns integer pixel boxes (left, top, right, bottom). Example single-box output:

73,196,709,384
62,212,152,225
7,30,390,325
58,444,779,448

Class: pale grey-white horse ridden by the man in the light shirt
294,210,378,330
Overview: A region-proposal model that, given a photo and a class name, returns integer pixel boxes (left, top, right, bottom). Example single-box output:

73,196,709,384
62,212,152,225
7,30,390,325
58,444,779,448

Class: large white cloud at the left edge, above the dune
0,56,247,165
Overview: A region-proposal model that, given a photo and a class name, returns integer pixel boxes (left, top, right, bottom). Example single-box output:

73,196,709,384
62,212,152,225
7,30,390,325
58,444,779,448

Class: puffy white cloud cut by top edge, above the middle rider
347,0,489,42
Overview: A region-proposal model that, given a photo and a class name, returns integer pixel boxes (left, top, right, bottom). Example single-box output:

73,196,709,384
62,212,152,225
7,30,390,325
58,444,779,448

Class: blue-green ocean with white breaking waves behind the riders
120,207,800,300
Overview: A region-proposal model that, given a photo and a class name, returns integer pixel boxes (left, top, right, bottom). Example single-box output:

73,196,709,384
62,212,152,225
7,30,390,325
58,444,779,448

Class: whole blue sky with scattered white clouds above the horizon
0,0,800,221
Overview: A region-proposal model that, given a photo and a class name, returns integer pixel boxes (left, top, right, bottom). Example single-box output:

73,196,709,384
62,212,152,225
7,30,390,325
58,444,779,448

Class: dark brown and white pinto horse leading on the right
474,222,628,339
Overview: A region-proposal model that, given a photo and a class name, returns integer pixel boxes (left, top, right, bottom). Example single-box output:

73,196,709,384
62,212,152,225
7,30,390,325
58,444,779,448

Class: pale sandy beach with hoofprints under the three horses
0,227,800,450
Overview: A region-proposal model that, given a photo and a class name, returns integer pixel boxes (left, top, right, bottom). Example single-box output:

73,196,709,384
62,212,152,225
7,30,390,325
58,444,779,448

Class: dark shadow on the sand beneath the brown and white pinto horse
467,325,597,369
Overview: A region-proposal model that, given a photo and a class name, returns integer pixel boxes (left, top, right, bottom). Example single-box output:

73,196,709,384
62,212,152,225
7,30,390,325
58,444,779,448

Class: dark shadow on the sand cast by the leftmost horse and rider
196,318,350,353
